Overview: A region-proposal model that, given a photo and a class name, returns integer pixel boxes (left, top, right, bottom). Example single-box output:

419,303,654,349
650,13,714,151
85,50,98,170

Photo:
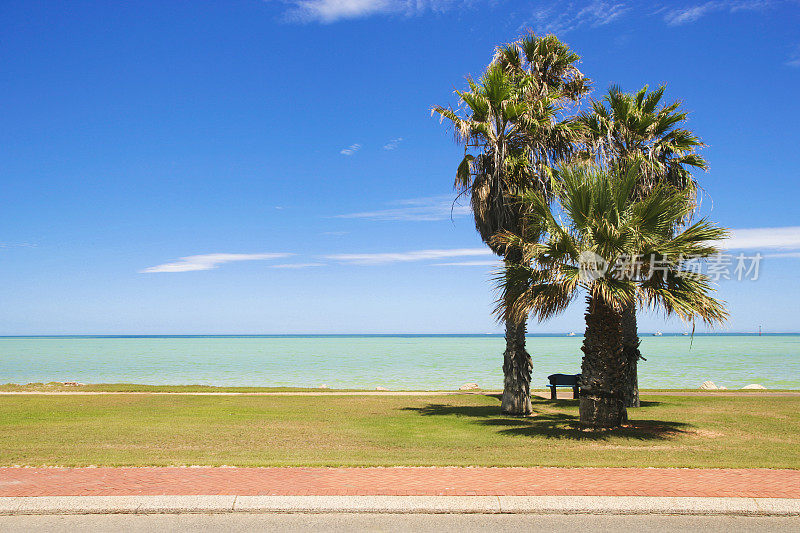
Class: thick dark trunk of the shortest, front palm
579,296,628,428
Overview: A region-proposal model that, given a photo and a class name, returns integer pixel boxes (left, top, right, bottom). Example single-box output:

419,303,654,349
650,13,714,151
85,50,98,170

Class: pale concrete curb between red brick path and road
0,496,800,516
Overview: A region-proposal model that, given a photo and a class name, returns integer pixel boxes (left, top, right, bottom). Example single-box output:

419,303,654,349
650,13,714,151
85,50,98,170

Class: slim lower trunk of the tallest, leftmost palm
500,319,533,416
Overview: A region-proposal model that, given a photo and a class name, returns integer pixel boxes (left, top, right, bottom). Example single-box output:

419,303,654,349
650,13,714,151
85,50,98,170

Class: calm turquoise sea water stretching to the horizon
0,335,800,389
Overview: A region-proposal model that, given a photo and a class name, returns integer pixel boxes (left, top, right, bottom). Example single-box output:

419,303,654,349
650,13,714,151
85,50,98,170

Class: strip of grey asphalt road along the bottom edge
0,513,800,533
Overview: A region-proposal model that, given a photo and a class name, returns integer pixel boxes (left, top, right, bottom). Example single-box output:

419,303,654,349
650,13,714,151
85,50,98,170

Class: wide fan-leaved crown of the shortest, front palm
496,162,727,324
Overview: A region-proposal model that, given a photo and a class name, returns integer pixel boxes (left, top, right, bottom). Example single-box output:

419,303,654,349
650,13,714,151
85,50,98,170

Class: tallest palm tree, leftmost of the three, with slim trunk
433,34,588,416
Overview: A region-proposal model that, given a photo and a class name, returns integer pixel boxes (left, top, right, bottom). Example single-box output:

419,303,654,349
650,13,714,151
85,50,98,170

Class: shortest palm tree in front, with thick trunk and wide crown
495,162,727,427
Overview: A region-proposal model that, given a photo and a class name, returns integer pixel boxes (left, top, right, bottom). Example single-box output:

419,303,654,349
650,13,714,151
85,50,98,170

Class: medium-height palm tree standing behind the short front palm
578,85,707,407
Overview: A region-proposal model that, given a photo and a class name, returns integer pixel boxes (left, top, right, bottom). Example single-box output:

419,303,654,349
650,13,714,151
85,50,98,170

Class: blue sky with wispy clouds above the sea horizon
0,0,800,335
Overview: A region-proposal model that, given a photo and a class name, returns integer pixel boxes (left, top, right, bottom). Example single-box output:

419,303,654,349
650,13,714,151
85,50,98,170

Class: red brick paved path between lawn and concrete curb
0,467,800,498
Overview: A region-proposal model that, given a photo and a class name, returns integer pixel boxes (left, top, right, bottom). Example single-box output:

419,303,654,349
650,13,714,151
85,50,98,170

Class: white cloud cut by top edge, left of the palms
284,0,469,24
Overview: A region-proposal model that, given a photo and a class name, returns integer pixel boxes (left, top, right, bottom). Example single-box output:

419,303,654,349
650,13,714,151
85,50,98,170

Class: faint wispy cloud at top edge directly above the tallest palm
523,0,630,34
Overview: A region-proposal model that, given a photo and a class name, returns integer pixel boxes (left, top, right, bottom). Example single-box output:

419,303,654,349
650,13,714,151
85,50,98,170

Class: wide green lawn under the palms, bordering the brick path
0,394,800,468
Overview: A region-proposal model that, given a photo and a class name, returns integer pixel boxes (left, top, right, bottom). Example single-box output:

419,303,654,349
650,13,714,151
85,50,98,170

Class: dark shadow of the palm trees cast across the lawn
403,400,692,441
